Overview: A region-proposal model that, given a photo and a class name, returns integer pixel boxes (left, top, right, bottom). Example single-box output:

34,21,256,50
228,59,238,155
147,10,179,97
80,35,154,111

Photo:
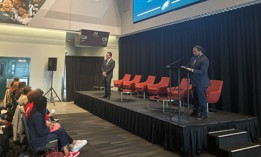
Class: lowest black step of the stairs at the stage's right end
217,143,261,157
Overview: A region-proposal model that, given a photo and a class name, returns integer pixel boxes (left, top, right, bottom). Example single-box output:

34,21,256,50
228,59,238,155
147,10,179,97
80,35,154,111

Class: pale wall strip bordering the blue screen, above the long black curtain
121,0,255,35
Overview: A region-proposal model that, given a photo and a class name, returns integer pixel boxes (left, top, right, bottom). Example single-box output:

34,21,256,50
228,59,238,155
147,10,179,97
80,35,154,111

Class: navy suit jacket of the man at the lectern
186,55,210,88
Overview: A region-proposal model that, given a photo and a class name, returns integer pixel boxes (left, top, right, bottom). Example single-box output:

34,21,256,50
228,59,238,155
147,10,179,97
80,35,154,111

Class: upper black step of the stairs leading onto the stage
207,129,249,155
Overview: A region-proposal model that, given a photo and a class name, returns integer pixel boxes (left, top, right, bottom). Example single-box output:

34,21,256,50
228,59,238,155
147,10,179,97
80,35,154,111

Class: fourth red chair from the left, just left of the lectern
147,77,169,99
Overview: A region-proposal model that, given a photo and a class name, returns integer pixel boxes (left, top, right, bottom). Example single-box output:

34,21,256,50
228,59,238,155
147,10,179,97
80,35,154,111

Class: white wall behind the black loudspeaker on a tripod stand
0,25,65,98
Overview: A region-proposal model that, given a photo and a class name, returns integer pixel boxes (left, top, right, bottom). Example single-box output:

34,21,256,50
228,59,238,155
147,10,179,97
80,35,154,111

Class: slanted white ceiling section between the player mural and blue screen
26,0,125,35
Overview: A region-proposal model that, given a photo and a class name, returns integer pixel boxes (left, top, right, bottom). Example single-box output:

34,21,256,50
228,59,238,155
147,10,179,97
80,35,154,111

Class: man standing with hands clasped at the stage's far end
102,52,115,99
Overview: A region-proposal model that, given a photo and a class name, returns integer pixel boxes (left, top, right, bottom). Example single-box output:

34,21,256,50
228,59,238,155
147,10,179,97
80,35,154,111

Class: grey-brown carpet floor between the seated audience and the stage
57,112,213,157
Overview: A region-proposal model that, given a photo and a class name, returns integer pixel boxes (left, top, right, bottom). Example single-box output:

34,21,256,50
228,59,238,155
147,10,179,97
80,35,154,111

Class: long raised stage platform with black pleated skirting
74,91,259,156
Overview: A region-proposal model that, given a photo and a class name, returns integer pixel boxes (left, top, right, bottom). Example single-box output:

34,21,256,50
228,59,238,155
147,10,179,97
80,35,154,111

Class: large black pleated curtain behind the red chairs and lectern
119,4,261,131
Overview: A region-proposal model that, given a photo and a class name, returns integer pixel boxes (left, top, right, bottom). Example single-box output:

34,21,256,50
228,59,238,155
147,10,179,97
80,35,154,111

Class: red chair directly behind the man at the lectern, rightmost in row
206,80,223,112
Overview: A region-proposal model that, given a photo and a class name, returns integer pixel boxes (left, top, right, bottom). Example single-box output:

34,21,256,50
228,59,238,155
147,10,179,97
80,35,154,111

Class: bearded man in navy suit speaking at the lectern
182,45,210,120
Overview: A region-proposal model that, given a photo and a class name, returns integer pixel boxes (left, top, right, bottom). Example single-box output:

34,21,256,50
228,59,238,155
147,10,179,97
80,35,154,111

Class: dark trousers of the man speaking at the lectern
193,87,207,116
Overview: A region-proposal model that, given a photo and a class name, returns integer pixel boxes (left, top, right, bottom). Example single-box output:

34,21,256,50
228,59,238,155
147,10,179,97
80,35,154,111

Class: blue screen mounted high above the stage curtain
133,0,206,23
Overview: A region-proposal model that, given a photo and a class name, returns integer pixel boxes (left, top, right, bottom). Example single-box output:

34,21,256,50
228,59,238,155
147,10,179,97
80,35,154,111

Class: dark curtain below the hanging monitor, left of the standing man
65,56,104,101
